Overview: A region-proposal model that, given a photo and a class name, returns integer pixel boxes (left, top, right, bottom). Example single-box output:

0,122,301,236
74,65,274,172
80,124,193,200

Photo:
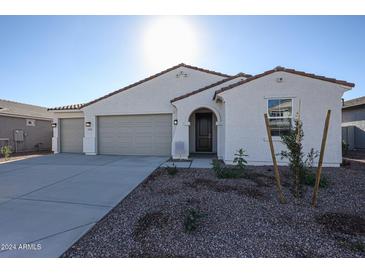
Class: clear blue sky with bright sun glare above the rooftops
0,16,365,107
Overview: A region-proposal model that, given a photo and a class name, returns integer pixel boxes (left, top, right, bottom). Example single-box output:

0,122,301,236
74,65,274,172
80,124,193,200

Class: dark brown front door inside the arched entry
195,113,213,152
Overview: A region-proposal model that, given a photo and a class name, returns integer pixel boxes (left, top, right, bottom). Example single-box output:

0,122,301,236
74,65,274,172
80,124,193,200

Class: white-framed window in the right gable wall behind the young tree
267,99,293,136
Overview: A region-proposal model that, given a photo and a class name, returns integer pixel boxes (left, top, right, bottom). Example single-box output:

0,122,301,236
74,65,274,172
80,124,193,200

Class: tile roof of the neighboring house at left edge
0,99,52,119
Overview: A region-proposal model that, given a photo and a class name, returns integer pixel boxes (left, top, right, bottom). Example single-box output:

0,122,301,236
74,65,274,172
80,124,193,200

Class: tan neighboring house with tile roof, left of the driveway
0,99,52,152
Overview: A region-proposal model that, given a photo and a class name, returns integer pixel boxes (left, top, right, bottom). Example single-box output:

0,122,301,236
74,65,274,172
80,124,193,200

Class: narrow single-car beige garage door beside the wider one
60,118,84,153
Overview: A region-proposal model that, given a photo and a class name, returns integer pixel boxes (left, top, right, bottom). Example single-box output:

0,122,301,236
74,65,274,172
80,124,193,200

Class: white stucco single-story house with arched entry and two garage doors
50,64,354,166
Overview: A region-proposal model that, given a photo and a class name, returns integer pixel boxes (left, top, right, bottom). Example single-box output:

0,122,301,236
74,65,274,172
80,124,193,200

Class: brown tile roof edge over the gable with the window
213,66,355,99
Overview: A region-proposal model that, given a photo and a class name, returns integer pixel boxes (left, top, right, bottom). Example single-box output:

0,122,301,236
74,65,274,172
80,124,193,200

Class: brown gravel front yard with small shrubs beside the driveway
63,163,365,257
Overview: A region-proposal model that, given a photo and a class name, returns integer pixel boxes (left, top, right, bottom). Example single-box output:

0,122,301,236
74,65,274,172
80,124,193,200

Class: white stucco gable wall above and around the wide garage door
83,68,224,155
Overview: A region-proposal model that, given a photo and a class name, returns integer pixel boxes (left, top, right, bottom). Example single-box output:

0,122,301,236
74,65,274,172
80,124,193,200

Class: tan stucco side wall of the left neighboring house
0,116,52,152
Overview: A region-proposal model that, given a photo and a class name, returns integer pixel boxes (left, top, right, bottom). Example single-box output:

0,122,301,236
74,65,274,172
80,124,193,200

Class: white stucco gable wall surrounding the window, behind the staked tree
220,72,346,166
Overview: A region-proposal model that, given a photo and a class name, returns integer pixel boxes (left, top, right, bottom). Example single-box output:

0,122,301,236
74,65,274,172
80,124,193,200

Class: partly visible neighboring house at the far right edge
342,96,365,149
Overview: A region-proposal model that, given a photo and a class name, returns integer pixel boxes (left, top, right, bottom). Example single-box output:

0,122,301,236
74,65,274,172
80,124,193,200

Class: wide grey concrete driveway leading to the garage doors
0,154,167,257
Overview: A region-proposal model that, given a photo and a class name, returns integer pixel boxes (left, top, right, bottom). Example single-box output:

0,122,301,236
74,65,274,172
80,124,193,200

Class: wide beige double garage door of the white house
98,114,172,155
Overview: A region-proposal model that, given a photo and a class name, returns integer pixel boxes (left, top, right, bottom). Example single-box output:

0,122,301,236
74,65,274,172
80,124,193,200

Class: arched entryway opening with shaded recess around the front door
189,107,218,155
